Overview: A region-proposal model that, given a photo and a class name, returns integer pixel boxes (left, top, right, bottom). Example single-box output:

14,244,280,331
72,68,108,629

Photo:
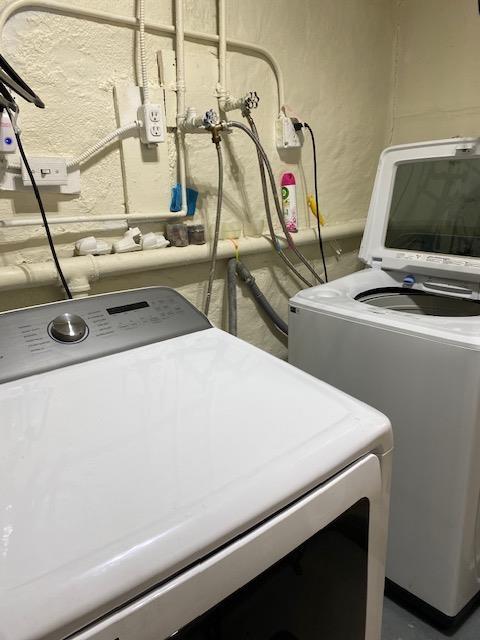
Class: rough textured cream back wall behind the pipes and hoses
0,0,394,355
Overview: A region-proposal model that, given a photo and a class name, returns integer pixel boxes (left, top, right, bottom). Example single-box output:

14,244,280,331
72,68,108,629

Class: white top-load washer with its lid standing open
289,138,480,618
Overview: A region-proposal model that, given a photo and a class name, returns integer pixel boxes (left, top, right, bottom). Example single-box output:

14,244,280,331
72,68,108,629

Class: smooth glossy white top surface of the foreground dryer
0,328,391,640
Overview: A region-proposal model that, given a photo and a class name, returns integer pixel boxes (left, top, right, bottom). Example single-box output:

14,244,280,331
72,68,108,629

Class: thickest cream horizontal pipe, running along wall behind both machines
0,220,365,295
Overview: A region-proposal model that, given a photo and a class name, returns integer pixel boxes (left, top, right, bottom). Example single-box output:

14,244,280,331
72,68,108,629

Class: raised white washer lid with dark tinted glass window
359,138,480,280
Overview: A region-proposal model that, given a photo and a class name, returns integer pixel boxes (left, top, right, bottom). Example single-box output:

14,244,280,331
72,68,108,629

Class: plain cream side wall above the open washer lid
392,0,480,143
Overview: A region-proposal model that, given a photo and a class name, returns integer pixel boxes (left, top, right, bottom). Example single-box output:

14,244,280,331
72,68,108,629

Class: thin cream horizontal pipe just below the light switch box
0,211,186,228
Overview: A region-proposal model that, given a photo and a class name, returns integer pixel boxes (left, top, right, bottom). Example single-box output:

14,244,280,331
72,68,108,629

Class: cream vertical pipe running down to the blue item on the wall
175,0,187,214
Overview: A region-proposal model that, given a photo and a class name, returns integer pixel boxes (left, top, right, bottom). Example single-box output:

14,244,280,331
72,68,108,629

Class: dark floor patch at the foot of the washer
382,598,480,640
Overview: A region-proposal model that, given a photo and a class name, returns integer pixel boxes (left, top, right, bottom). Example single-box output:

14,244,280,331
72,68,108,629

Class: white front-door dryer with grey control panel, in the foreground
0,287,392,640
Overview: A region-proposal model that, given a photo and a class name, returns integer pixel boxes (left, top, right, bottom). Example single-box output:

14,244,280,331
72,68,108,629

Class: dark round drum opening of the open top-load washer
355,287,480,318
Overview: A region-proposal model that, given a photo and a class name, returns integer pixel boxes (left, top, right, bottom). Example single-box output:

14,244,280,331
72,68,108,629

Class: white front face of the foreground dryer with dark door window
72,454,388,640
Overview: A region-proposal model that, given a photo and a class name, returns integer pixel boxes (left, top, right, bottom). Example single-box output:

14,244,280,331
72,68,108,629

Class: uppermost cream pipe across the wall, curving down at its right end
0,0,285,113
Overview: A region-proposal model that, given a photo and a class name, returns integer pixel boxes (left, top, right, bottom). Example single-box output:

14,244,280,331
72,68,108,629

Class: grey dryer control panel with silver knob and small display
0,287,212,382
